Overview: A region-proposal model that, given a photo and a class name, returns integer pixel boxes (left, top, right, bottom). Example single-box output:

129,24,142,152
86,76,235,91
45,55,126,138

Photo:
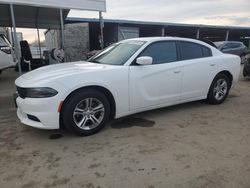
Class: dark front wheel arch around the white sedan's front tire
59,85,116,124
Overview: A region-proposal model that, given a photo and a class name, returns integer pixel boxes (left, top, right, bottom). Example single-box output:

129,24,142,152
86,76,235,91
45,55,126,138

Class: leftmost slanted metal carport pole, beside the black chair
10,4,22,76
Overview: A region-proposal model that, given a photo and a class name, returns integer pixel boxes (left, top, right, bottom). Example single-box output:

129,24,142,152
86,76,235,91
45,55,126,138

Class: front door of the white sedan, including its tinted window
129,41,182,110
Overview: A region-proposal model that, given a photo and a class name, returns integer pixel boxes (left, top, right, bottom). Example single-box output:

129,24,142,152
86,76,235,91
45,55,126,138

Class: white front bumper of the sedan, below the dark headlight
16,97,60,129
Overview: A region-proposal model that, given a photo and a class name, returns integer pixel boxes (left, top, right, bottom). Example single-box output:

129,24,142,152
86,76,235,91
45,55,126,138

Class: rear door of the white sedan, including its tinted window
178,41,217,100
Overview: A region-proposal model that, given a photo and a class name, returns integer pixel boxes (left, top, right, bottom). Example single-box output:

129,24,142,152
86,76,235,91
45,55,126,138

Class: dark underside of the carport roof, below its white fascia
0,4,69,29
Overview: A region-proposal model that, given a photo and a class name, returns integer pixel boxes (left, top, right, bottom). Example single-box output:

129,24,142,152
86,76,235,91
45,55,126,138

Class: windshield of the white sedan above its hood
88,40,145,65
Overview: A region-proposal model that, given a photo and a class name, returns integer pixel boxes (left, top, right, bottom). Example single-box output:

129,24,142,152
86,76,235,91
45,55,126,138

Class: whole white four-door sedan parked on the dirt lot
15,37,240,135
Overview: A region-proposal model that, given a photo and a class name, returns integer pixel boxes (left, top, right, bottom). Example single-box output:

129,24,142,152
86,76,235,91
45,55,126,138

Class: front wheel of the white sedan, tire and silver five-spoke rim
61,89,110,136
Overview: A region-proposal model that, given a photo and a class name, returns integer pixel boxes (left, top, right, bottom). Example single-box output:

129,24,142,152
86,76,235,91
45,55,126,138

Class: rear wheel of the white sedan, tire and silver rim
207,74,231,105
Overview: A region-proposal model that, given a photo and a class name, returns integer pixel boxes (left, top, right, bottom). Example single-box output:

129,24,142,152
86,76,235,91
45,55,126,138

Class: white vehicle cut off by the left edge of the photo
0,34,16,73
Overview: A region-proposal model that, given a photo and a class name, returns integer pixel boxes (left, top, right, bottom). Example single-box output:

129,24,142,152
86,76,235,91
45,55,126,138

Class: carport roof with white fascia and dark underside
0,0,106,29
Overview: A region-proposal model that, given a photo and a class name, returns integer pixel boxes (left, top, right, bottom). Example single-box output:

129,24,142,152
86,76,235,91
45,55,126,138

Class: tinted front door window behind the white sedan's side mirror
140,41,177,64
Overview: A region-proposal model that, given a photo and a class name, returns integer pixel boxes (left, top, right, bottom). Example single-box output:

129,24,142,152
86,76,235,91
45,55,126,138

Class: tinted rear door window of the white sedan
179,42,211,60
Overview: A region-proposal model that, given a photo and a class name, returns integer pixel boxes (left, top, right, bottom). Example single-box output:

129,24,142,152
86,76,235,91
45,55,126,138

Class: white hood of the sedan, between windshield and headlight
22,61,113,81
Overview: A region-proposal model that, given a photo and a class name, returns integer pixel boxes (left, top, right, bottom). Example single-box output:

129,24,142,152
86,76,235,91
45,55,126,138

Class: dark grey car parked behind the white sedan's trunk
215,41,248,63
